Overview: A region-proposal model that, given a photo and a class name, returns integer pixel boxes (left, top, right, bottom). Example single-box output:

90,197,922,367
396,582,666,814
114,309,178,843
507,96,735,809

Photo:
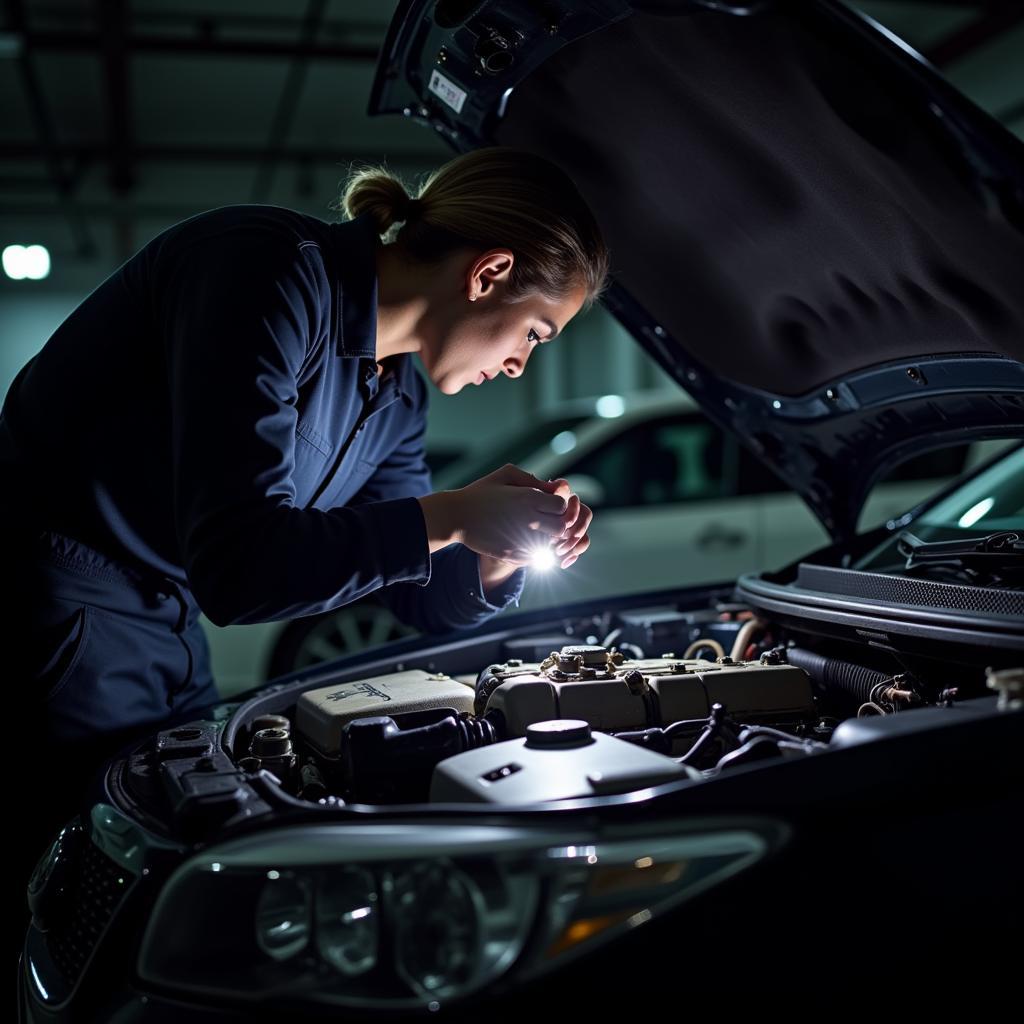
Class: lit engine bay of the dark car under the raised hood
203,600,1022,807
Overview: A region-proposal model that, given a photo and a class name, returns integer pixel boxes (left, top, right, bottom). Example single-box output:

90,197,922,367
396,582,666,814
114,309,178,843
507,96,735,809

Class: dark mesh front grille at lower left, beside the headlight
46,842,134,985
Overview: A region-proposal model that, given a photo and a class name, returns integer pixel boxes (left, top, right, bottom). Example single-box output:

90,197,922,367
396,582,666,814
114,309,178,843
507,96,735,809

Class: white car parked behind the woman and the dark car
203,391,998,695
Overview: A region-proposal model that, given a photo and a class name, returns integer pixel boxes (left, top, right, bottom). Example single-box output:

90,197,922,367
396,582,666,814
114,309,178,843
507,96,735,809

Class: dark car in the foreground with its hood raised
18,0,1024,1022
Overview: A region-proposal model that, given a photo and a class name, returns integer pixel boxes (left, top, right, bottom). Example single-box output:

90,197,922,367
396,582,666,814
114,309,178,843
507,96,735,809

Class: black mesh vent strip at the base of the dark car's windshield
797,565,1024,618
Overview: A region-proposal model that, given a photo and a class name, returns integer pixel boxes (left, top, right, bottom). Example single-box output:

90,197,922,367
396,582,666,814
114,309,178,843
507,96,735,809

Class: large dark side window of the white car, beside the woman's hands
563,414,734,508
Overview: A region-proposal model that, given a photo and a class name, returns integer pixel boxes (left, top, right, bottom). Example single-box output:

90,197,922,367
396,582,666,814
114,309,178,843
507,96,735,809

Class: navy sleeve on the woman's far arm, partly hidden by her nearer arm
350,375,525,633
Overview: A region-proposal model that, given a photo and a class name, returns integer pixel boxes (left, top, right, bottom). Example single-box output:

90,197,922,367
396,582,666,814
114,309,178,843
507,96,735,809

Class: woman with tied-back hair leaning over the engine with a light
0,148,607,765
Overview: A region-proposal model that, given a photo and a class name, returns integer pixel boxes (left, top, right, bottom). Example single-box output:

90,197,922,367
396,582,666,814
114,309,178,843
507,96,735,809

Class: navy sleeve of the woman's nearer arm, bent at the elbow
155,229,431,626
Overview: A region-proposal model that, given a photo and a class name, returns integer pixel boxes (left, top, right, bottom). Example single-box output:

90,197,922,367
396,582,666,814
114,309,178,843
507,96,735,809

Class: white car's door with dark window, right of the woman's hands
522,413,756,607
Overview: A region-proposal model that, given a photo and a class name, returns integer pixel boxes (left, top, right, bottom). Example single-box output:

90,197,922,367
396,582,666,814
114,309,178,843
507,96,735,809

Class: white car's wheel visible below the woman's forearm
266,602,417,679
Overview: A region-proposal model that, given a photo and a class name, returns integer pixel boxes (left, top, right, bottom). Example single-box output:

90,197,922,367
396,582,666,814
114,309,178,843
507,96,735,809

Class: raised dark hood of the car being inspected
370,0,1024,540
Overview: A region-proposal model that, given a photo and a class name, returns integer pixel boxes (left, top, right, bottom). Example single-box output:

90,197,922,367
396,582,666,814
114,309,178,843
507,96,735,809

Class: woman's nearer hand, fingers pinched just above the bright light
447,463,579,565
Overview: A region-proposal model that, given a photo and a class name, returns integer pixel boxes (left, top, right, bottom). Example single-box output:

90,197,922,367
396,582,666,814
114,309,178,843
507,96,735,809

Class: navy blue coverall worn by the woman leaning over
0,206,523,742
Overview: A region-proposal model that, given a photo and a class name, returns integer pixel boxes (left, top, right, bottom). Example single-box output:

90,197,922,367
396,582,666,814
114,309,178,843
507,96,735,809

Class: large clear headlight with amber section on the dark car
139,820,785,1010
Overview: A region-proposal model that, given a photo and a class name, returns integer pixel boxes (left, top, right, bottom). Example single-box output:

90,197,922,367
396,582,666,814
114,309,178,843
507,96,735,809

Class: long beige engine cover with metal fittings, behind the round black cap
474,645,815,737
